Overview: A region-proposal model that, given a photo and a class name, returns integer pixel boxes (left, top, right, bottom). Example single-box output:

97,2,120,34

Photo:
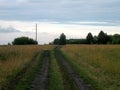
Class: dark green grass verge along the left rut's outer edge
13,52,44,90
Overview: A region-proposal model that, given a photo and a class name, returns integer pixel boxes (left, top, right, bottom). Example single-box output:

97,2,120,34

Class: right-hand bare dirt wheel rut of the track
54,47,90,90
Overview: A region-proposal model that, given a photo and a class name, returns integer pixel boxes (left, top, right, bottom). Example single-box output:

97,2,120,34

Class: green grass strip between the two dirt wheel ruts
48,51,64,90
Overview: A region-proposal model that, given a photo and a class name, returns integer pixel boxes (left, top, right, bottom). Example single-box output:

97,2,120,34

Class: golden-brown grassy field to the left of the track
0,45,53,87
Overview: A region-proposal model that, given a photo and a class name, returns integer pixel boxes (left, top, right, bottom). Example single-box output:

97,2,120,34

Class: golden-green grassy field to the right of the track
61,45,120,90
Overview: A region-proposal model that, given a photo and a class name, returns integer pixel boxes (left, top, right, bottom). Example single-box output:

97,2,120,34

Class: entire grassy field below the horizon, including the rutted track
0,45,120,90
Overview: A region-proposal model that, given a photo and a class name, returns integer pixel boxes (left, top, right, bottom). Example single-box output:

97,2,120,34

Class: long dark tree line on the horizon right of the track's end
53,31,120,45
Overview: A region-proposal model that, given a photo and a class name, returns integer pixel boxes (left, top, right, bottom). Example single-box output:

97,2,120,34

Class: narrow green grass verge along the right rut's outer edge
58,46,102,90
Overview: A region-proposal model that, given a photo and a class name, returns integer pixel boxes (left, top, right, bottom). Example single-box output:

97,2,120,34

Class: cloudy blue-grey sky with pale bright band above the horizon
0,0,120,44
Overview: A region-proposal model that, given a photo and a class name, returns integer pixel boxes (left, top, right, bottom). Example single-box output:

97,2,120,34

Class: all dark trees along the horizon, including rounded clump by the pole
12,31,120,45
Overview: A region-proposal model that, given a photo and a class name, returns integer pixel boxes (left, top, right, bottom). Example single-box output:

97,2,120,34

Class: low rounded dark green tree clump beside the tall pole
12,37,38,45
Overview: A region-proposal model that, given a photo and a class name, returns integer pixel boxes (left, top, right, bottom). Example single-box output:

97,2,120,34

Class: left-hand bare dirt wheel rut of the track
30,50,49,90
